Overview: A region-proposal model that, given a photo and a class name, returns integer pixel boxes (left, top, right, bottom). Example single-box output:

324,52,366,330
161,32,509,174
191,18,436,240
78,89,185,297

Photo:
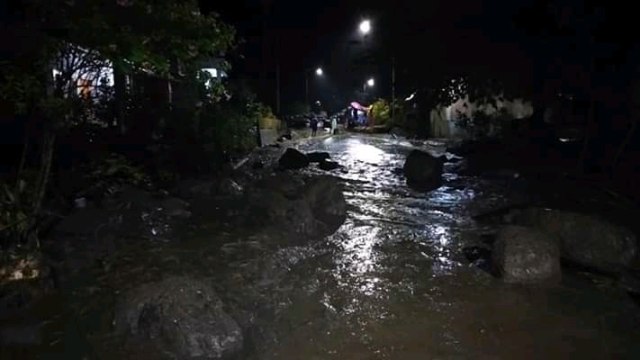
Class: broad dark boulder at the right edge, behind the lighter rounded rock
510,208,638,272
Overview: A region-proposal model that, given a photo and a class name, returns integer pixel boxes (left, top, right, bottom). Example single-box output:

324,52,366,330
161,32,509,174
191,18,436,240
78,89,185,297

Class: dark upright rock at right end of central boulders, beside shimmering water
304,176,347,233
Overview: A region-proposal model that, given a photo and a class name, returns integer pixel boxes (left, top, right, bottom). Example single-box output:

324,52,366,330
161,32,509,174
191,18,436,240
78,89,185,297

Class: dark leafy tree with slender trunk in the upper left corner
0,0,234,246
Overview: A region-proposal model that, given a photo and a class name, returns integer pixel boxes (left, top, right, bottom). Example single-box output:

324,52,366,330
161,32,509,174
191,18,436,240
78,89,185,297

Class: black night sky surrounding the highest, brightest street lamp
202,0,628,112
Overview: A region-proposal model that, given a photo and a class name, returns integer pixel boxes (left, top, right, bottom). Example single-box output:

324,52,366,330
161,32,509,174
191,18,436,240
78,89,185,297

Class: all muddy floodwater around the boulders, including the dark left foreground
1,135,640,359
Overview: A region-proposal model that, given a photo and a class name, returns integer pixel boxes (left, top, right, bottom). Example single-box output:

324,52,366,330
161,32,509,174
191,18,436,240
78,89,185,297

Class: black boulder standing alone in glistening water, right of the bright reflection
403,150,443,191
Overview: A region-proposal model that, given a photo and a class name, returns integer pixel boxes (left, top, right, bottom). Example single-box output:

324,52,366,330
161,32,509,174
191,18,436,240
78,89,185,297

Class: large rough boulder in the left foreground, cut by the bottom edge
115,277,243,359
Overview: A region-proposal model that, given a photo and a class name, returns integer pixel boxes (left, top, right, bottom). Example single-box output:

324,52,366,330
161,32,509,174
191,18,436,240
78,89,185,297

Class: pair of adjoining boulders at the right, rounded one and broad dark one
492,207,638,283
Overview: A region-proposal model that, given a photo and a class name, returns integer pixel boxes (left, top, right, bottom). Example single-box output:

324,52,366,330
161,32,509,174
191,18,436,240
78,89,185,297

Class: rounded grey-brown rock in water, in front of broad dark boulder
492,226,561,283
